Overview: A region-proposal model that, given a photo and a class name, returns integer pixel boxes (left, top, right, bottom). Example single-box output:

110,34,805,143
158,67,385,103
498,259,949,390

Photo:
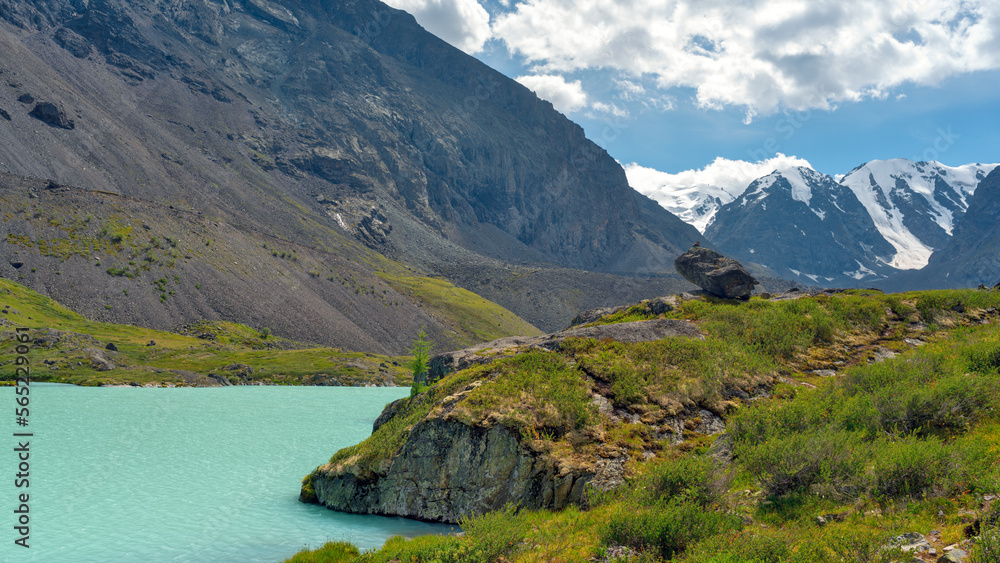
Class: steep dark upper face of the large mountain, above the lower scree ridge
0,0,699,348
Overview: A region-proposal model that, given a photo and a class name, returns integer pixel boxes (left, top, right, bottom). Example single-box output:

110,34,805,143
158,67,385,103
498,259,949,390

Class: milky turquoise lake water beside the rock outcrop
0,384,452,563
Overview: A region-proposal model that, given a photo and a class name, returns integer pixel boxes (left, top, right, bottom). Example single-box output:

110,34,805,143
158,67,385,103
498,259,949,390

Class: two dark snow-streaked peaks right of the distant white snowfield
692,159,996,287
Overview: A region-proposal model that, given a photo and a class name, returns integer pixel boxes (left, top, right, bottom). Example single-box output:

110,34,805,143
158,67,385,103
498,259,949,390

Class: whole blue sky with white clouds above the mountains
387,0,1000,194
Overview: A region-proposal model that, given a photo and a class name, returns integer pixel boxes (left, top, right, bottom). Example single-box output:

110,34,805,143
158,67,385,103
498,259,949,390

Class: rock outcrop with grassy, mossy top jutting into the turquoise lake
300,308,712,522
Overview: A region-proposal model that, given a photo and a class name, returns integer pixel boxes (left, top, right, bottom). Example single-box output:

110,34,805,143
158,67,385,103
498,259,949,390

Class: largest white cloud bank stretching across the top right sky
493,0,1000,120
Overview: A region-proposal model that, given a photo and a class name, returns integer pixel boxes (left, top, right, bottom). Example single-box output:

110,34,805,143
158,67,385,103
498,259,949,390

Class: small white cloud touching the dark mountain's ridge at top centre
386,0,491,53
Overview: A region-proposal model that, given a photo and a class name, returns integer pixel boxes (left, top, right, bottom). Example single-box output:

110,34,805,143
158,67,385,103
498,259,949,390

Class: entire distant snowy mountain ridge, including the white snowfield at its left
626,158,998,284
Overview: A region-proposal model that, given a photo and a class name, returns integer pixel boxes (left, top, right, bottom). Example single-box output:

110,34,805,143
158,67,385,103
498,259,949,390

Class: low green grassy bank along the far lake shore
0,279,411,385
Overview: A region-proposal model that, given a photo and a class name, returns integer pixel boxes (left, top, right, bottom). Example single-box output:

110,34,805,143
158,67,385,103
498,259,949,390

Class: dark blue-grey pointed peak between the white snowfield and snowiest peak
705,167,894,287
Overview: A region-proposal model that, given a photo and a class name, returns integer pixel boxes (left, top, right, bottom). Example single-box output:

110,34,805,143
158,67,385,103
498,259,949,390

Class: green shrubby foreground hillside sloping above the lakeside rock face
289,290,1000,563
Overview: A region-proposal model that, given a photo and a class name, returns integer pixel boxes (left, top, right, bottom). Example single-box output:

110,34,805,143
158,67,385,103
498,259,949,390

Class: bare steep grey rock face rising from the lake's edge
312,418,593,522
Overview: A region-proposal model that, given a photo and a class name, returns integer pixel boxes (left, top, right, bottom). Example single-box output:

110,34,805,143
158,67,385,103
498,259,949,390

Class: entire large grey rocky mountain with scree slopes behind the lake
0,0,700,351
